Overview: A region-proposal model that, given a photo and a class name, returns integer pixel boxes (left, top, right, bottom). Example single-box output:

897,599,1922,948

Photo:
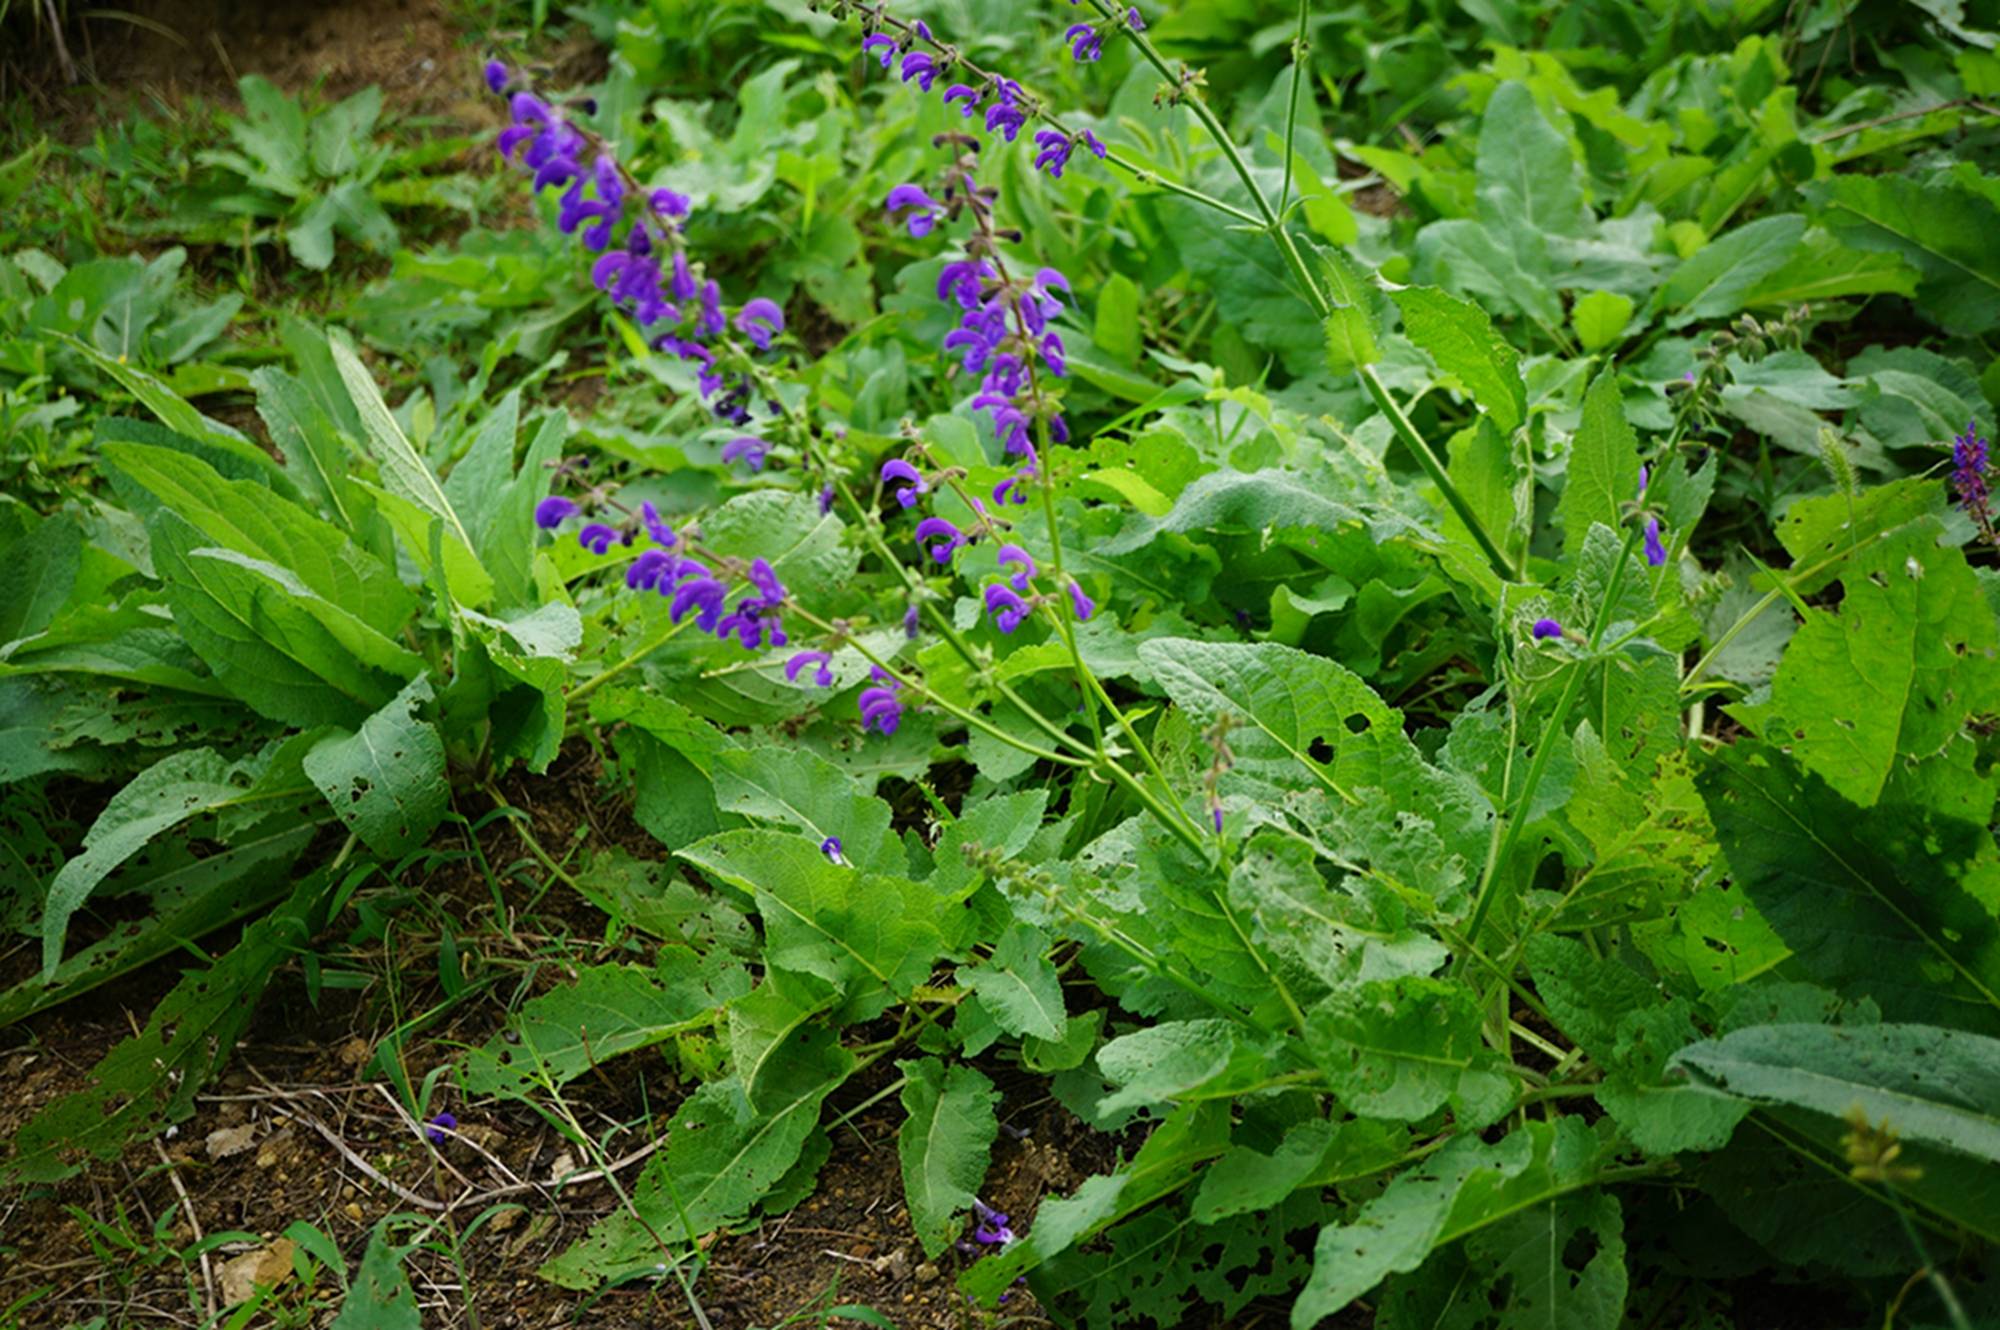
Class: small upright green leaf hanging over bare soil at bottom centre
896,1058,1000,1260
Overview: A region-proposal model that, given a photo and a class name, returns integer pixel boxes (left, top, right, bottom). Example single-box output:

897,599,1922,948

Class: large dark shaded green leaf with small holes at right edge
1698,742,2000,1034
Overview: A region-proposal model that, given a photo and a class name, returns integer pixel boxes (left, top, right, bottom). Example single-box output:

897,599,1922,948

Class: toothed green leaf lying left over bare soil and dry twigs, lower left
462,948,728,1098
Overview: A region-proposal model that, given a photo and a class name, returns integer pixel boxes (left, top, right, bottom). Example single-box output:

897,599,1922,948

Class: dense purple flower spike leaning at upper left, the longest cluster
486,60,784,422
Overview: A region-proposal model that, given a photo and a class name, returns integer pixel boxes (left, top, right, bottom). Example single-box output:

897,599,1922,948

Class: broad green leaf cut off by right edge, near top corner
1804,174,2000,336
